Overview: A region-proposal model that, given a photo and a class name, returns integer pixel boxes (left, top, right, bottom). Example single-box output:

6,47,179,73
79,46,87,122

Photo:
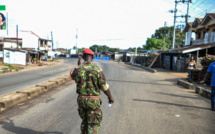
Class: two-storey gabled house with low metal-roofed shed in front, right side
160,13,215,72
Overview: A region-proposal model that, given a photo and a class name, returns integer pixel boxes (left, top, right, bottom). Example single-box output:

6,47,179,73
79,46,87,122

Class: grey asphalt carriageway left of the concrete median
0,58,77,96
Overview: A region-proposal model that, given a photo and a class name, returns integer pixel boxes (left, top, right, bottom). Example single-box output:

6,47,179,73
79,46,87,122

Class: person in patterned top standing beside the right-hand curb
186,56,196,83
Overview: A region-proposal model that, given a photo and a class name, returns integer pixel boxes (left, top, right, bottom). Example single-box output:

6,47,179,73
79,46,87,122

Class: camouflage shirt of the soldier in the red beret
72,63,109,96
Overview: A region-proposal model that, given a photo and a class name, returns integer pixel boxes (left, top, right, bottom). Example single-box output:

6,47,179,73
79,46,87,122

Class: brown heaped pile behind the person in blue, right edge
198,54,215,85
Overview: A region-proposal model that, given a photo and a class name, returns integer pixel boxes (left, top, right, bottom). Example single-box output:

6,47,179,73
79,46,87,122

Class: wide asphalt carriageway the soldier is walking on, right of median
0,62,215,134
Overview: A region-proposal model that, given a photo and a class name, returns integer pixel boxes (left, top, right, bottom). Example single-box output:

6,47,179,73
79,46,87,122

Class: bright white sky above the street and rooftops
0,0,215,49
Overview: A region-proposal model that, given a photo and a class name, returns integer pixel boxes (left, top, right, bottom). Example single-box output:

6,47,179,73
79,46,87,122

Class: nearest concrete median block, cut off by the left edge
0,93,28,111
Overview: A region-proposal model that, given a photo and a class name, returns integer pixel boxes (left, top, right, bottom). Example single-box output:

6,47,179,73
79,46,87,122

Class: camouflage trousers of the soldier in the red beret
77,96,102,134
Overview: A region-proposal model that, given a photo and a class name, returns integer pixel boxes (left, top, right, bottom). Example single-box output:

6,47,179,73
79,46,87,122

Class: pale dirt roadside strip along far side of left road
0,59,64,75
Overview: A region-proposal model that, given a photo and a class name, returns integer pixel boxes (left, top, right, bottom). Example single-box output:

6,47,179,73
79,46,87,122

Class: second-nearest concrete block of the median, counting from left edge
16,86,45,99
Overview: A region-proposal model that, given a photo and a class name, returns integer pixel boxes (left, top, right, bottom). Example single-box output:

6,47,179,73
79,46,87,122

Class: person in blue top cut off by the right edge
199,61,215,111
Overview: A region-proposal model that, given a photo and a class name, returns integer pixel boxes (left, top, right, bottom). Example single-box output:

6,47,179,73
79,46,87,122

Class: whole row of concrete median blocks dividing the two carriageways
0,75,71,111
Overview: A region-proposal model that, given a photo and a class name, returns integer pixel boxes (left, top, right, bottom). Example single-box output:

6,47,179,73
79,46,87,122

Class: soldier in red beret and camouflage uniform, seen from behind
71,48,114,134
